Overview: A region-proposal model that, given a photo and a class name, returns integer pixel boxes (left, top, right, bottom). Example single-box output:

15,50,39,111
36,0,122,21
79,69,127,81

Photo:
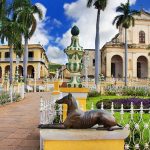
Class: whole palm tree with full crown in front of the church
113,0,140,86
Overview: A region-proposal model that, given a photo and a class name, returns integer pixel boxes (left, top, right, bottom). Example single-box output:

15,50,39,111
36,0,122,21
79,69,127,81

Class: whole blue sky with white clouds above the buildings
7,0,150,64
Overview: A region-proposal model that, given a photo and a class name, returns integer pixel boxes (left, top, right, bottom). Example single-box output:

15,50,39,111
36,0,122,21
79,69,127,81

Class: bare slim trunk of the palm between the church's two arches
125,28,128,86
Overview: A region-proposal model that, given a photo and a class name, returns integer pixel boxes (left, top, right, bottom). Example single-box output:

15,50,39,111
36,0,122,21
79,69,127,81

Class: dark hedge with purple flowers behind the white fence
96,98,150,109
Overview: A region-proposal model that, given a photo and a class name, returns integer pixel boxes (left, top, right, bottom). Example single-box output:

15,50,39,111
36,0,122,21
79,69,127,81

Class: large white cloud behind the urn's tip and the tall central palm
58,0,136,48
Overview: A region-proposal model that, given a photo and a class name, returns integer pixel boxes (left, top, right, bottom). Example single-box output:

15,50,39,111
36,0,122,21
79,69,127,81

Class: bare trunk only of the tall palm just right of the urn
95,9,100,90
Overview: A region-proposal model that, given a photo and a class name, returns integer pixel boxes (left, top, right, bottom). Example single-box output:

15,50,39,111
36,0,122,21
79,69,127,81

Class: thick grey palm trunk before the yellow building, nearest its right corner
23,38,28,85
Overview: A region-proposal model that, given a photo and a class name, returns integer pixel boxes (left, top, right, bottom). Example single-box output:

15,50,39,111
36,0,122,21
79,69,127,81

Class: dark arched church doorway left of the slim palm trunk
111,55,123,78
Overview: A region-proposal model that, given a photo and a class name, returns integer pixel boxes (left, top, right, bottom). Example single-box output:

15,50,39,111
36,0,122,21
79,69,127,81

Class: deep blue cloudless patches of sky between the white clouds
32,0,150,41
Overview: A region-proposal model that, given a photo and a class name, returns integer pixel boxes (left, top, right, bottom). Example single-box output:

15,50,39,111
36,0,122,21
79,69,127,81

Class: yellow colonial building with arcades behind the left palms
0,44,49,79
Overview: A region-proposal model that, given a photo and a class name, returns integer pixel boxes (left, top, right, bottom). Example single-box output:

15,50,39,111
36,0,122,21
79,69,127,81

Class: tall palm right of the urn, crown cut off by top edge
87,0,107,90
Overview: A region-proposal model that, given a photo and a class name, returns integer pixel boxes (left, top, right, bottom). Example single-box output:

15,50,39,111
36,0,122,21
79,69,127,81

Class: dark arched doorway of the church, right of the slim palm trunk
137,56,148,78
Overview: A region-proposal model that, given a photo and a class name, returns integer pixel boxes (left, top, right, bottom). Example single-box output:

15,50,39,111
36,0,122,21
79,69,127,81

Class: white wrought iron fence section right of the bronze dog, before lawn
96,102,150,150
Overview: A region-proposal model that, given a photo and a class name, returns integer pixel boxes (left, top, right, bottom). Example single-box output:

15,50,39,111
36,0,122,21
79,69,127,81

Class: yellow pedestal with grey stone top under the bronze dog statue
40,129,129,150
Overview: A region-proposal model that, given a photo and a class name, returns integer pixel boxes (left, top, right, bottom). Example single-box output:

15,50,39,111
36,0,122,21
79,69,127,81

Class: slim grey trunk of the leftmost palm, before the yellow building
9,45,13,84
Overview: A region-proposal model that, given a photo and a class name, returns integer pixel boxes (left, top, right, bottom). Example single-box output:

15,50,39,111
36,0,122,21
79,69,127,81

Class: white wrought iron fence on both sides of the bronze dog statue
40,97,150,150
